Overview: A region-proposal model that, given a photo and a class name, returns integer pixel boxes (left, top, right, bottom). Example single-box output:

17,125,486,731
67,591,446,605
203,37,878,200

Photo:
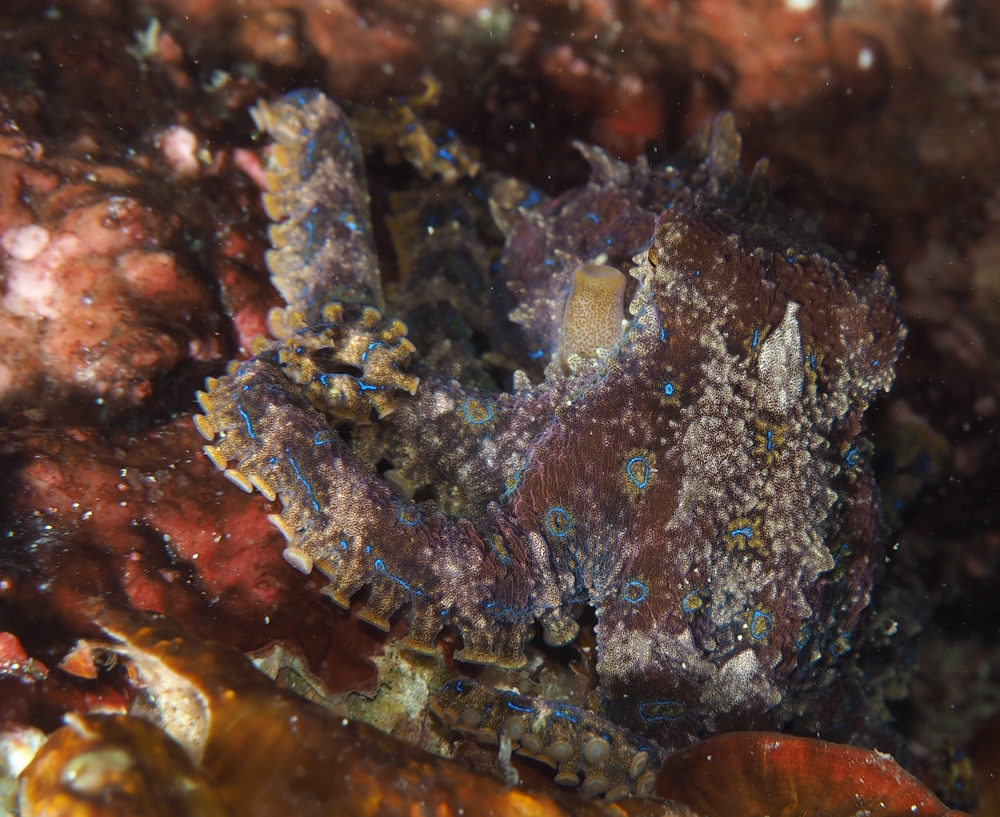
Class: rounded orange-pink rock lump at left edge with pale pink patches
0,139,223,422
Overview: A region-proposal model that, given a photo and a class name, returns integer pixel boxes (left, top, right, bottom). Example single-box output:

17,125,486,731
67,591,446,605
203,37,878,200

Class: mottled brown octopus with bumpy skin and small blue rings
197,92,905,792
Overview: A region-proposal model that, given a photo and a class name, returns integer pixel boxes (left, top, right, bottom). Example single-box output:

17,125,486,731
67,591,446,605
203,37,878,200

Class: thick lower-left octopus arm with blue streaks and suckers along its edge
198,346,533,666
